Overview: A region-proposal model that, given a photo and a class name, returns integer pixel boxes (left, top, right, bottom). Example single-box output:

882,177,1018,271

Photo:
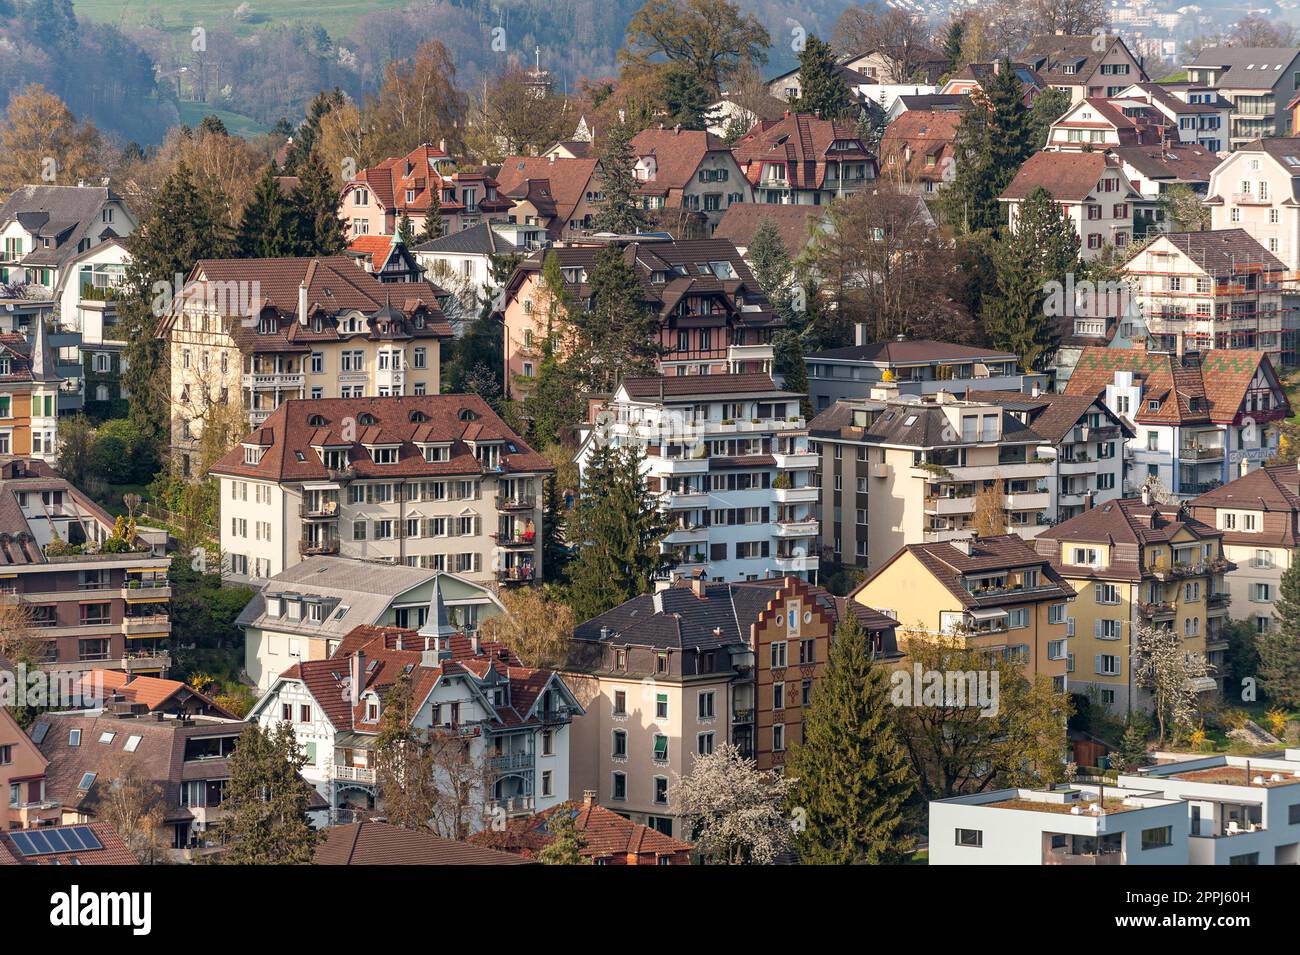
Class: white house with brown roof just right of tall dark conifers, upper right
1000,151,1149,255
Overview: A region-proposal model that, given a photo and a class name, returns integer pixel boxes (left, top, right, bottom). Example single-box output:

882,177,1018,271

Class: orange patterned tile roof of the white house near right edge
1065,347,1291,425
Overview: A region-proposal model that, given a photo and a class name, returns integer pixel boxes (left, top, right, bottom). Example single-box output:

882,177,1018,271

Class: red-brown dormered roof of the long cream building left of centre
212,395,551,482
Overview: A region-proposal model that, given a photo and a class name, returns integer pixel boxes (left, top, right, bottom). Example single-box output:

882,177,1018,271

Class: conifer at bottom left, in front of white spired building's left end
220,722,316,865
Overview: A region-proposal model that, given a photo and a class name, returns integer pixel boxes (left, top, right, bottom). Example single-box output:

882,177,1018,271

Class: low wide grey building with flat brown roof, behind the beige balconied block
803,325,1047,412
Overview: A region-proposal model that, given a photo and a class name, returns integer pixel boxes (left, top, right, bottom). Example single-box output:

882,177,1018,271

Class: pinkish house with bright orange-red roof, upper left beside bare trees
338,143,512,236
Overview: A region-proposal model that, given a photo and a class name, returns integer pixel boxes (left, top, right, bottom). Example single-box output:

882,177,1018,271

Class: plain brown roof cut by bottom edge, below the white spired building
316,820,530,865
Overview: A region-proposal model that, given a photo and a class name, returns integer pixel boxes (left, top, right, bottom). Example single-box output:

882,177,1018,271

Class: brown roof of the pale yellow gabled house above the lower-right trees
849,534,1075,609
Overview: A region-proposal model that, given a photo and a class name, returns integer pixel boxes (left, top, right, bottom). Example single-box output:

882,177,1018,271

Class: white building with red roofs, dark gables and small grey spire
248,608,584,832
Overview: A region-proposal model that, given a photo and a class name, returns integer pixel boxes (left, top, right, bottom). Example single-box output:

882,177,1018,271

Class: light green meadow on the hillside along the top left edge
73,0,411,38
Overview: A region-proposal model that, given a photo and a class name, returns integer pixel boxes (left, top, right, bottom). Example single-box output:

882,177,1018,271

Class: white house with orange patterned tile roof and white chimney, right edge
1066,348,1291,496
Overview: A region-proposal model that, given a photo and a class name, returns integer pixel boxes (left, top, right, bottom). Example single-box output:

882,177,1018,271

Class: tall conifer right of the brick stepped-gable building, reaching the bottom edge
788,611,915,865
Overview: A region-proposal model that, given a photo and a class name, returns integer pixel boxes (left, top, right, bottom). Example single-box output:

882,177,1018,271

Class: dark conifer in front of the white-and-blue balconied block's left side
566,444,672,620
